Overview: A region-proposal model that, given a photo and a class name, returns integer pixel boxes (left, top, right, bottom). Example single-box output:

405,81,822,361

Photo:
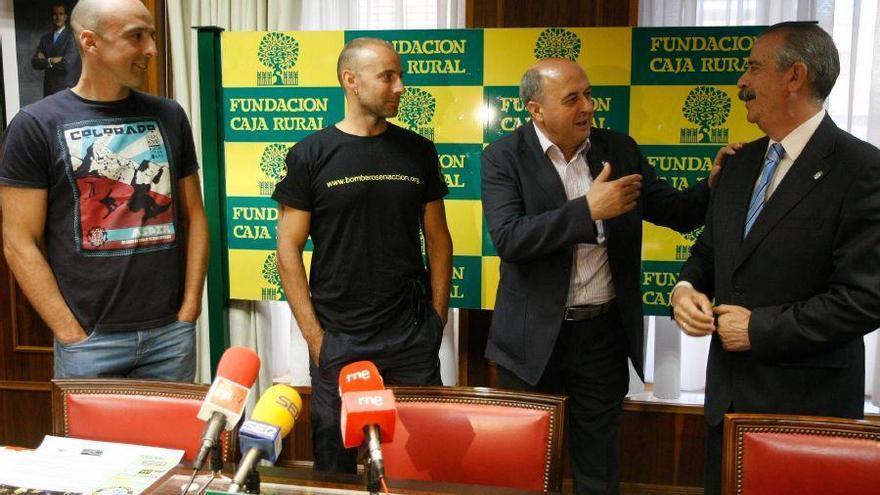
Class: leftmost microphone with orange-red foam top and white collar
193,347,260,472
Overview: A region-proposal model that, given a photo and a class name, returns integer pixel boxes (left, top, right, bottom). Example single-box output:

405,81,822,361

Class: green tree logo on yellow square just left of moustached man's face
680,86,731,144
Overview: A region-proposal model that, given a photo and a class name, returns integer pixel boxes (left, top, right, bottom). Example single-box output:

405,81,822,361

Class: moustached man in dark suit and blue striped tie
672,23,880,494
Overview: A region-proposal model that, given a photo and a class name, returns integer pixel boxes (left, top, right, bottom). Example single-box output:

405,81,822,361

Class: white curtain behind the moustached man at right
639,0,880,406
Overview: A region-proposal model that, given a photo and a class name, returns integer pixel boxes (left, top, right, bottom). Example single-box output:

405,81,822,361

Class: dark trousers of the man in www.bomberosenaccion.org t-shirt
309,303,443,473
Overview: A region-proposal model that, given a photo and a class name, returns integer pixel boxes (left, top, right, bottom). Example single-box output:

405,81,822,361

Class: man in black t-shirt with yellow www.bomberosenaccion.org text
273,38,452,472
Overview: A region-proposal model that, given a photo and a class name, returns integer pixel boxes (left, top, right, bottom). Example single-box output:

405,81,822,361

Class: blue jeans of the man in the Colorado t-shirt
55,321,196,382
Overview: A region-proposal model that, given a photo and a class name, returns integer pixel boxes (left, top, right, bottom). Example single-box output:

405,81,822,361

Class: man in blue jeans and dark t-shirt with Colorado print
0,0,208,381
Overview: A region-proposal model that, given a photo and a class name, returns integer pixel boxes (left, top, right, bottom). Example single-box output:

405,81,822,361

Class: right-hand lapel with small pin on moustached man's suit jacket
737,115,837,265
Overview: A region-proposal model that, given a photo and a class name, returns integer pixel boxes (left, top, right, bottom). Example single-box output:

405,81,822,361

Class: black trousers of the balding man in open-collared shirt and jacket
498,306,629,495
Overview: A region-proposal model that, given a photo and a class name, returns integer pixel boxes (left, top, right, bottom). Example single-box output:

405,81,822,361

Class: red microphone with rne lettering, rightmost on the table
339,361,397,481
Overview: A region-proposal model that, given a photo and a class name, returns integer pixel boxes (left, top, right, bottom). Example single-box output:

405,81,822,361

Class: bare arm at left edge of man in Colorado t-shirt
0,186,86,344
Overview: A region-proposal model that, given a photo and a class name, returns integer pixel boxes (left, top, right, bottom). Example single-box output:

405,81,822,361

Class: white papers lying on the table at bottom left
0,436,183,495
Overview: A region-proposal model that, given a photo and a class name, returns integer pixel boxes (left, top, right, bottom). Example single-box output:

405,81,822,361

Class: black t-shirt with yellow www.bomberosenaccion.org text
272,124,448,333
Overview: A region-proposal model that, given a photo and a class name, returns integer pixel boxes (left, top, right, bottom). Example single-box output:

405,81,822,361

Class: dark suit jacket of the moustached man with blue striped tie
680,117,880,424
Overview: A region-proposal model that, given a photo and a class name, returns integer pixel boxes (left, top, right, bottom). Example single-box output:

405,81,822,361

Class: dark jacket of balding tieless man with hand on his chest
482,123,709,384
